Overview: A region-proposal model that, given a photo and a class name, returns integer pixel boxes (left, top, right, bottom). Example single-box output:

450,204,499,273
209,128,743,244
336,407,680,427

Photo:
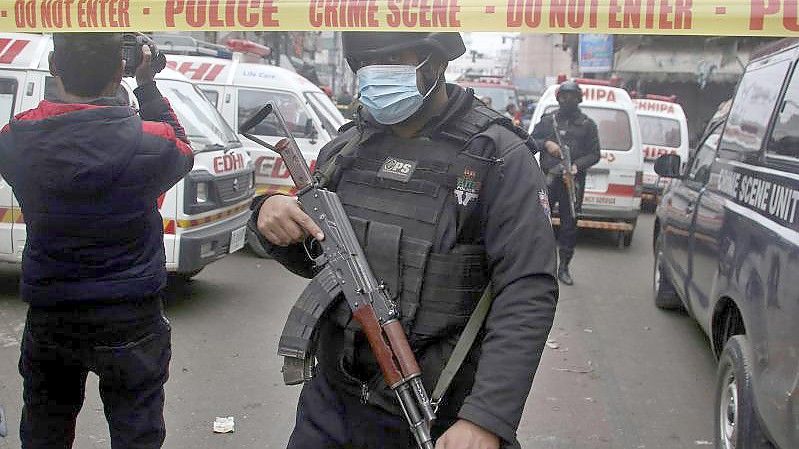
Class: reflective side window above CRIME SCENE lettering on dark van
720,60,790,158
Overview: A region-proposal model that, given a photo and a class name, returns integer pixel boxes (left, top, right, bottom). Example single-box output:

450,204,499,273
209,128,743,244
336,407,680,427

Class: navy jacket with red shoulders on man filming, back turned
0,84,194,306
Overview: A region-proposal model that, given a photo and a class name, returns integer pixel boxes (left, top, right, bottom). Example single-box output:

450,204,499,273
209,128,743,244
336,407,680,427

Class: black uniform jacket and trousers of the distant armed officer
532,111,601,259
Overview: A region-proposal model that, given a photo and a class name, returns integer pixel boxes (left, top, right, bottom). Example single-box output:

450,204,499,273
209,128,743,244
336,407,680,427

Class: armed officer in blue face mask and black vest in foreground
253,32,558,449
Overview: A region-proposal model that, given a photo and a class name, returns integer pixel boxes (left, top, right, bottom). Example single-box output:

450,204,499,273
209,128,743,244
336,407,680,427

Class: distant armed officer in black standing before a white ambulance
532,81,601,285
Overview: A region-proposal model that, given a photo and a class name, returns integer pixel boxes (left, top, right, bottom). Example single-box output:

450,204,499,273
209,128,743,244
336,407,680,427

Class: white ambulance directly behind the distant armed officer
530,77,644,247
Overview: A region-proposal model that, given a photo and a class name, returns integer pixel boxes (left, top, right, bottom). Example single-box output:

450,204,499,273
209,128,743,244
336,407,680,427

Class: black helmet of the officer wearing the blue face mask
341,31,466,72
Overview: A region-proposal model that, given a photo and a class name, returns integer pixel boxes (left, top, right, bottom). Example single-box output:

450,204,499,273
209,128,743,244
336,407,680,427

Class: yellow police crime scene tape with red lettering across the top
0,0,799,36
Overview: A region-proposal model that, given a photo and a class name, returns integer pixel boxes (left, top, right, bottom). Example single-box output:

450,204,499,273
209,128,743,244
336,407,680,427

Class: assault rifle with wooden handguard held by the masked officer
239,103,435,449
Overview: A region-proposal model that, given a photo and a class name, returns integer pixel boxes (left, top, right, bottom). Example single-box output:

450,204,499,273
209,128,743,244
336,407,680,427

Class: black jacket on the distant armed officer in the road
531,111,602,178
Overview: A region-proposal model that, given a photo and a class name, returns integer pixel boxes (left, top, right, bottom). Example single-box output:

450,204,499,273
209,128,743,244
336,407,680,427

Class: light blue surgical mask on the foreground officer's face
356,58,436,125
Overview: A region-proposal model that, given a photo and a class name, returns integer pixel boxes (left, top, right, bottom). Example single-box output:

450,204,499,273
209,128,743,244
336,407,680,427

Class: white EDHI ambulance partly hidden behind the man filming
0,33,255,278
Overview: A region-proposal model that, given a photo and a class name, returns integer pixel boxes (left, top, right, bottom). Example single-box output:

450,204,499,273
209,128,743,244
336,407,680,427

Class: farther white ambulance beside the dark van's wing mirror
633,95,688,205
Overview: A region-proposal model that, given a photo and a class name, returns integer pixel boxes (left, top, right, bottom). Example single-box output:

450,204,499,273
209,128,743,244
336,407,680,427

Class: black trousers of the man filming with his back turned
19,299,172,449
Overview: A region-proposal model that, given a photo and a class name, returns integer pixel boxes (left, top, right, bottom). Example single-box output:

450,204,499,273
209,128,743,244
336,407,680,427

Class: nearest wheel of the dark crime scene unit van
715,335,772,449
